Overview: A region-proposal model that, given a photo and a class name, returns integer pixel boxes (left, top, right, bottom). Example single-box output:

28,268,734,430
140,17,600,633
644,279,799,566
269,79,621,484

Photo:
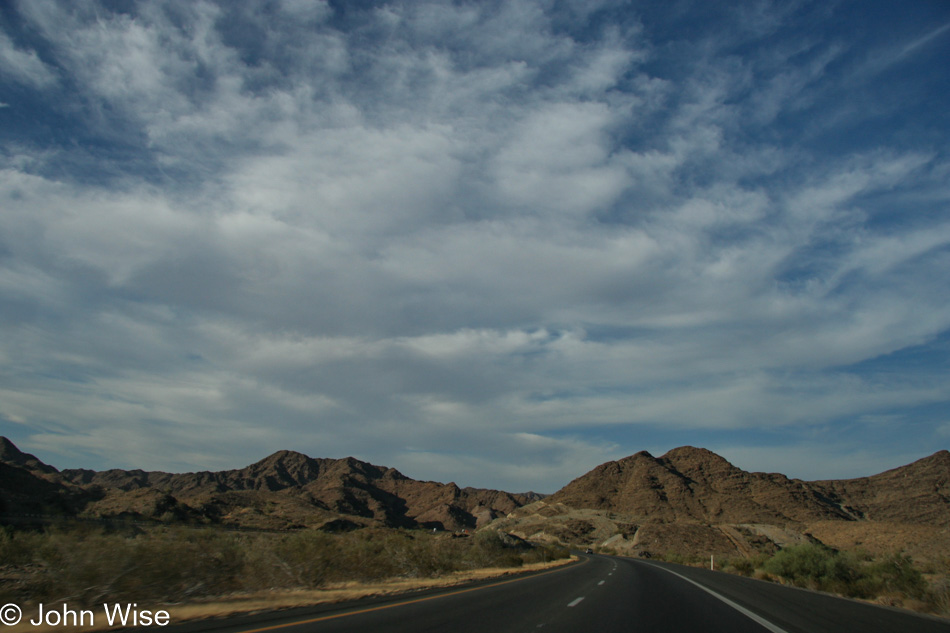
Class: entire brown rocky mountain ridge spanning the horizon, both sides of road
0,438,950,551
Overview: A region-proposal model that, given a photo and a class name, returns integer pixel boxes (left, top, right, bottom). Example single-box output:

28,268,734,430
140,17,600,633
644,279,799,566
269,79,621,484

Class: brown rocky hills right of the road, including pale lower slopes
493,446,950,560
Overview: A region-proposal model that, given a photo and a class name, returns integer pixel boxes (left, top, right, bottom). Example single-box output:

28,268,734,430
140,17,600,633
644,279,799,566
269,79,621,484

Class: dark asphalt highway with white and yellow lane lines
165,556,950,633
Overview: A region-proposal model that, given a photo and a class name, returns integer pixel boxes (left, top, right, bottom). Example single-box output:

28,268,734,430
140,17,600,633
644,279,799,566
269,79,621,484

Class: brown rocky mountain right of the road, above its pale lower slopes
547,446,950,526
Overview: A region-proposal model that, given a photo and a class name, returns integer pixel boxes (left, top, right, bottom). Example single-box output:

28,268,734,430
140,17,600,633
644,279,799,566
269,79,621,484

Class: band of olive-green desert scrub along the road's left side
0,528,569,606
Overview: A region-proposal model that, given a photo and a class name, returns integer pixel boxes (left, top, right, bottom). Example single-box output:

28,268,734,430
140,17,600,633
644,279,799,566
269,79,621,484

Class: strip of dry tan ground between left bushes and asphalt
3,556,577,633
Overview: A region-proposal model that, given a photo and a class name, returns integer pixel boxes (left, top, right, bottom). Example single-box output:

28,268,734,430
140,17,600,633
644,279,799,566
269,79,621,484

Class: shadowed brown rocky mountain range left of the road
0,438,533,530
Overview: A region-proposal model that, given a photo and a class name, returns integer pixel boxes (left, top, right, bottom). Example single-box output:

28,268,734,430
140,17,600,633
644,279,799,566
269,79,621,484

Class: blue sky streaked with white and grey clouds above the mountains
0,0,950,493
